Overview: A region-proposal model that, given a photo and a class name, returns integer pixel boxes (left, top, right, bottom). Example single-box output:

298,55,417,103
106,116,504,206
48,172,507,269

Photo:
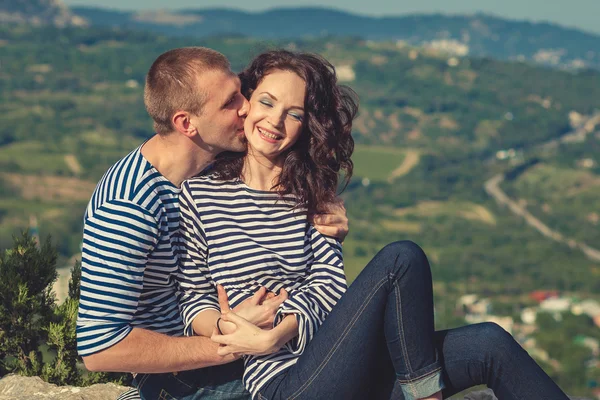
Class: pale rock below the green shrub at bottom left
0,375,129,400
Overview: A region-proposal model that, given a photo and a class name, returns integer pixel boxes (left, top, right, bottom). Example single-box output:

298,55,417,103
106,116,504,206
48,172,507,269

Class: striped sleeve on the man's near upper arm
76,200,159,356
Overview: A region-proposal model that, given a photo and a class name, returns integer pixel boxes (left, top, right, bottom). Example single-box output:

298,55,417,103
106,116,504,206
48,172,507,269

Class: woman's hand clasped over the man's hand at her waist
210,311,282,356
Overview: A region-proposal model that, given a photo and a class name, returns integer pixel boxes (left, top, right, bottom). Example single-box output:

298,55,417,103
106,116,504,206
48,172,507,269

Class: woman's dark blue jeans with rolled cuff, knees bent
259,241,567,400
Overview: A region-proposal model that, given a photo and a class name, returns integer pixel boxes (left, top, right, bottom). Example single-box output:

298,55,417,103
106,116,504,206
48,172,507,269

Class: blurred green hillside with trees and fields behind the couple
0,26,600,394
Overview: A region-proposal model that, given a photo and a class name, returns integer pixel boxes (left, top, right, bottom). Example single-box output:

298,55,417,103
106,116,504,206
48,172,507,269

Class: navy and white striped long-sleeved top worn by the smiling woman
179,176,346,397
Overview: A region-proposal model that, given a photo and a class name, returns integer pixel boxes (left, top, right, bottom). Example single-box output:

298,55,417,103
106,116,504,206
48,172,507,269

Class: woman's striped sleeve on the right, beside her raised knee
274,226,347,355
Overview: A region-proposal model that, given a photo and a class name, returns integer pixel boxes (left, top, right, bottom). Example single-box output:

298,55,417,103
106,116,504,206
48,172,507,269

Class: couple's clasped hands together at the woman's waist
211,285,288,357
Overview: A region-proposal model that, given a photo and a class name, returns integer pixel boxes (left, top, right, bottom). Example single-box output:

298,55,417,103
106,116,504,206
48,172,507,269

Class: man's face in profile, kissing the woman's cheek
191,70,248,155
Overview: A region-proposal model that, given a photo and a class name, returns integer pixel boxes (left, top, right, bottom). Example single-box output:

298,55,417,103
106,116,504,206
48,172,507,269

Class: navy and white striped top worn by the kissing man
77,146,183,356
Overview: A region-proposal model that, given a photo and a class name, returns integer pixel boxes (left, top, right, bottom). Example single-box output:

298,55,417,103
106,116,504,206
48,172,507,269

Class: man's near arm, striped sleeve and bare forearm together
77,200,235,373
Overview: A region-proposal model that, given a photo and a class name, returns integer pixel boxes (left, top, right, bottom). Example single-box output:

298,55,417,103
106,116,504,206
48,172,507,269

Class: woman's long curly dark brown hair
213,50,358,214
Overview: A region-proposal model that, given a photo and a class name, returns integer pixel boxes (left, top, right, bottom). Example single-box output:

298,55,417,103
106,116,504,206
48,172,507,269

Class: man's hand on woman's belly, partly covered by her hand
217,285,288,333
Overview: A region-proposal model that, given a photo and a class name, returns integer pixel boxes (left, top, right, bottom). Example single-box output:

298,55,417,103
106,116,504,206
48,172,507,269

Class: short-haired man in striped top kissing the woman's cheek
77,47,347,398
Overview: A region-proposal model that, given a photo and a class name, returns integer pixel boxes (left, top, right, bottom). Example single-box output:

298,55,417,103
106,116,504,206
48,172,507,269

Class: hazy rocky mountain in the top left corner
0,0,87,27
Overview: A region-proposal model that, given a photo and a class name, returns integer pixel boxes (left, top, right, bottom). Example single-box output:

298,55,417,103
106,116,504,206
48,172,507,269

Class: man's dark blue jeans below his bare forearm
133,361,250,400
